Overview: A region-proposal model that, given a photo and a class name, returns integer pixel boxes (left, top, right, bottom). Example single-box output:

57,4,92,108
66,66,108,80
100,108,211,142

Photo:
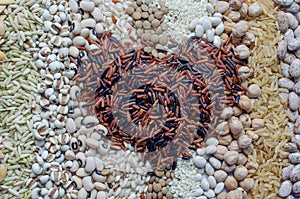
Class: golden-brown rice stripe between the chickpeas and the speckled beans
246,0,290,199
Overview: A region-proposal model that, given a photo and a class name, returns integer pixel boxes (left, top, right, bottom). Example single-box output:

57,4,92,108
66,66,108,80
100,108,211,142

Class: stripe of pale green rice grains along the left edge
0,0,43,198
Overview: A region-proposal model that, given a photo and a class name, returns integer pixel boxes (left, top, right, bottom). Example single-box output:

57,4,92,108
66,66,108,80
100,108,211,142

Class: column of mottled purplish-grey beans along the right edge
275,0,300,197
